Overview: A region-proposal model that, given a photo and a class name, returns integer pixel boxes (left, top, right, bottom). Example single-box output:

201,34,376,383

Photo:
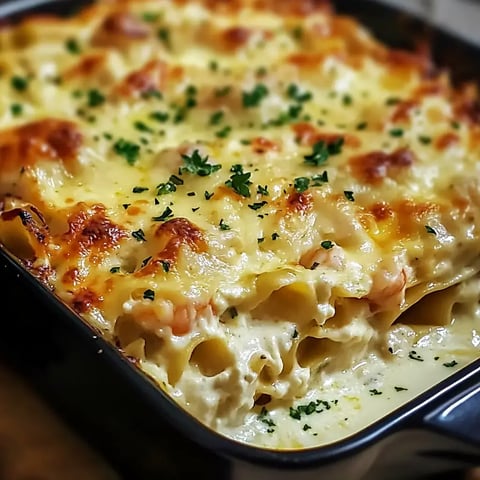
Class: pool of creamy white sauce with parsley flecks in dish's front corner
219,321,479,449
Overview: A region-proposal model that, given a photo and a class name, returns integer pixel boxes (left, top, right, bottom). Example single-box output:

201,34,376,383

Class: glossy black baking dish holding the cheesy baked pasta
0,0,480,480
